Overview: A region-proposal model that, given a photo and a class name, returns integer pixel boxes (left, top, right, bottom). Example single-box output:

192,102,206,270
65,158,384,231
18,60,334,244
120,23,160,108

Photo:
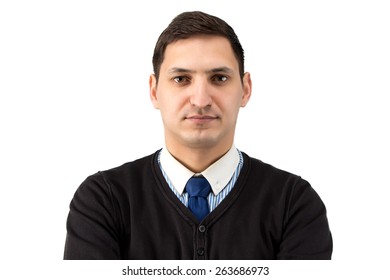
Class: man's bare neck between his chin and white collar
166,143,232,173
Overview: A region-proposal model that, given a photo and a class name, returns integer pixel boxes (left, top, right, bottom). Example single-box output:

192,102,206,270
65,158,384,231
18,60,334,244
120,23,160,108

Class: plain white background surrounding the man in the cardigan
0,0,390,279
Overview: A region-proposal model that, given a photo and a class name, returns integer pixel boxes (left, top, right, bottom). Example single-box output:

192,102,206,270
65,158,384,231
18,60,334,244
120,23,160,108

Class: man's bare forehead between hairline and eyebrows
161,35,238,70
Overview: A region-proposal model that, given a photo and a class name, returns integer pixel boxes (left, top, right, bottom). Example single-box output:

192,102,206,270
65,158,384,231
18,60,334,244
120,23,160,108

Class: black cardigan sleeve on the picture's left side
64,173,120,260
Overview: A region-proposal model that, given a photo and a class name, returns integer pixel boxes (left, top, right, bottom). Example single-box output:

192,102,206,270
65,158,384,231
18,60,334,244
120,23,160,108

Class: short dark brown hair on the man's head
153,11,244,81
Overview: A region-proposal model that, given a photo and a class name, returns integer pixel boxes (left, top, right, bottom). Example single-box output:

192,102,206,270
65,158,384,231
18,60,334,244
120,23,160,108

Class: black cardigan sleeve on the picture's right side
277,178,333,260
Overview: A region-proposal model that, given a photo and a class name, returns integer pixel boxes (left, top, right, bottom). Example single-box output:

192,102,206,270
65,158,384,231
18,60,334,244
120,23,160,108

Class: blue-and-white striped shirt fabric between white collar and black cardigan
157,149,244,212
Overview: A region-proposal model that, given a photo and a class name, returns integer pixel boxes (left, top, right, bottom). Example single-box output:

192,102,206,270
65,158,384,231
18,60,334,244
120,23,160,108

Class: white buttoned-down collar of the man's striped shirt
160,145,240,195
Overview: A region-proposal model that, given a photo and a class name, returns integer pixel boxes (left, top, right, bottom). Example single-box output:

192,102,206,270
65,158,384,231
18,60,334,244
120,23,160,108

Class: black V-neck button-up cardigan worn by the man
64,152,332,259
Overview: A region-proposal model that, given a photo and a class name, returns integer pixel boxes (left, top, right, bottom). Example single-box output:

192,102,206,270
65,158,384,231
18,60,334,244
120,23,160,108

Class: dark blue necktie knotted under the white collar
186,176,211,221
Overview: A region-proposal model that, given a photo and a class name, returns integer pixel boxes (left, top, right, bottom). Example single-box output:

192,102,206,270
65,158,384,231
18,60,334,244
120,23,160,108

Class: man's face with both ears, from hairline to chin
150,35,251,153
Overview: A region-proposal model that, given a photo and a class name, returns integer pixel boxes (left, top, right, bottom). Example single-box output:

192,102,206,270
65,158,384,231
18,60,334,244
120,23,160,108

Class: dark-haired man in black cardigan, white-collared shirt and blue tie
64,12,332,259
